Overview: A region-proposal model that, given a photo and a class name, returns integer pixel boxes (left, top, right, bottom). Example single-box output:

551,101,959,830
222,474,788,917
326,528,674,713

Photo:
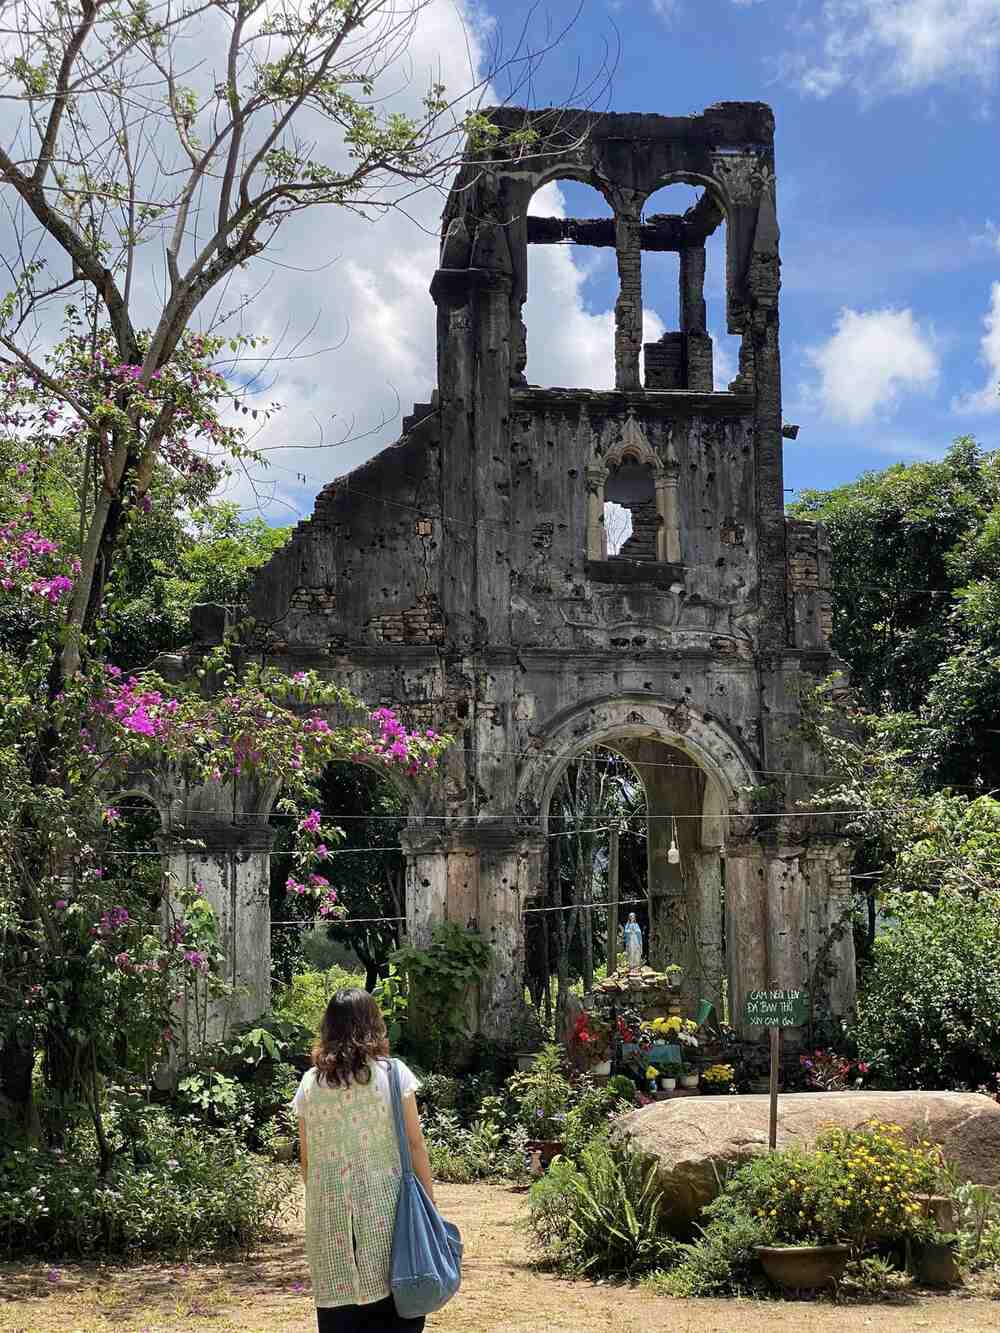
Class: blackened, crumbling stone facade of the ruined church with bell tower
182,103,853,1033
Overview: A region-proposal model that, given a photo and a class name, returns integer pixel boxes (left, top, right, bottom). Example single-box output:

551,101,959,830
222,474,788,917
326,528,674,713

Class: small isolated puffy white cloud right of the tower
807,309,939,425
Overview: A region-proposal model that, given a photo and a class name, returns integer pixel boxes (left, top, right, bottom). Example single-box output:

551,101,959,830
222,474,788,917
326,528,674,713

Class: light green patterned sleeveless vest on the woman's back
303,1072,400,1308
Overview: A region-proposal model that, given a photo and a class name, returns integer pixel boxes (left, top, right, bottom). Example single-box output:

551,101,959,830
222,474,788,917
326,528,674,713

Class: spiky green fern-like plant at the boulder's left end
528,1136,679,1277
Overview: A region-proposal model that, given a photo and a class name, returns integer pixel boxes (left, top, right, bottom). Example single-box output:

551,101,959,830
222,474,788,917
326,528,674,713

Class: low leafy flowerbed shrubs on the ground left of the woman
0,1114,295,1261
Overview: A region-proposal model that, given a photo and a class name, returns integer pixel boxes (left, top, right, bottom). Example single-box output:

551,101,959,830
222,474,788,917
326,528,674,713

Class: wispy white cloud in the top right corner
781,0,1000,99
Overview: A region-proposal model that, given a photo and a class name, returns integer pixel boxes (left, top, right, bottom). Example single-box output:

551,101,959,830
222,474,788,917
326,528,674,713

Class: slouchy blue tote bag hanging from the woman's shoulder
389,1060,461,1320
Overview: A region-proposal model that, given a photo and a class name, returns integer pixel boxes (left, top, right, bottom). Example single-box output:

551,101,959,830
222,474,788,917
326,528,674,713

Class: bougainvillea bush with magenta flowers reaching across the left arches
0,474,445,1151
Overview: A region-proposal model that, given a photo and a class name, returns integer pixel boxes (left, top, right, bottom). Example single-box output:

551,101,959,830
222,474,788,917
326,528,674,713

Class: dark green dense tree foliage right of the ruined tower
792,437,1000,790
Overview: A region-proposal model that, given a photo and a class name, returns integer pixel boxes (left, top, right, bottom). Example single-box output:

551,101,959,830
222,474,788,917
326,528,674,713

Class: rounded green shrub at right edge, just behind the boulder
856,890,1000,1088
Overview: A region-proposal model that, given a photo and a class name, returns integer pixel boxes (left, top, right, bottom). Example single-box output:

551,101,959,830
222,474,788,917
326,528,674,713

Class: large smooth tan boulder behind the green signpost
619,1092,1000,1232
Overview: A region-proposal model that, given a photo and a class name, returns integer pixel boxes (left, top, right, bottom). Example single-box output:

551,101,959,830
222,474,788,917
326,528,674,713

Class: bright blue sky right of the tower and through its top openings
503,0,1000,501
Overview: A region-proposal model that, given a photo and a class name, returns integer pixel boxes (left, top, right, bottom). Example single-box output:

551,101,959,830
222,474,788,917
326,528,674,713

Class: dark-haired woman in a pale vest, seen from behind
292,990,433,1333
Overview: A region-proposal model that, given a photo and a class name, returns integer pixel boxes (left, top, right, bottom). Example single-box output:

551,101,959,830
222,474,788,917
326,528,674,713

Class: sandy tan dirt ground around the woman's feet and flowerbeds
0,1185,1000,1333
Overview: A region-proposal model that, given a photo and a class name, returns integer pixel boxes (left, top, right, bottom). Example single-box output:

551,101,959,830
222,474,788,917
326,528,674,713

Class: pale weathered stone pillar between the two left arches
160,818,275,1061
